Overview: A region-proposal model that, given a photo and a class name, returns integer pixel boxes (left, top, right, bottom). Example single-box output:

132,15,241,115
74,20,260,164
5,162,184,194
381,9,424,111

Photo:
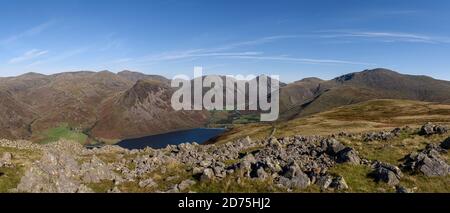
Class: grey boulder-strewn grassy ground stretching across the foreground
0,123,450,193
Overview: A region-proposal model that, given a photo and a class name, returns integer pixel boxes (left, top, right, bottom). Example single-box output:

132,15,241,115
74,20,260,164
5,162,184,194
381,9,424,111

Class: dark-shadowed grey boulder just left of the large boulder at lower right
372,162,403,186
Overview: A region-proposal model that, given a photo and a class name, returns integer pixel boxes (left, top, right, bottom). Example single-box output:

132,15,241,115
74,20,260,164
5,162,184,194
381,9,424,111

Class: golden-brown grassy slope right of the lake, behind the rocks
216,99,450,143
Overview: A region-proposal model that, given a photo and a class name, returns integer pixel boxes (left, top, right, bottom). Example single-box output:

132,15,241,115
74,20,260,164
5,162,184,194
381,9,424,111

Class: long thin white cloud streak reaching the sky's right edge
318,31,450,44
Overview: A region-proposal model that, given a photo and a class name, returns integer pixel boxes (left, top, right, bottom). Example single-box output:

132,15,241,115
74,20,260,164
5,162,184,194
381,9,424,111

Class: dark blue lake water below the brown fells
117,128,225,149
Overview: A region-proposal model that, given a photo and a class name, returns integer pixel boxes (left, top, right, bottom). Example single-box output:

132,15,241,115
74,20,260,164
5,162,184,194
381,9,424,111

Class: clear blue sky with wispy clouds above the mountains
0,0,450,82
